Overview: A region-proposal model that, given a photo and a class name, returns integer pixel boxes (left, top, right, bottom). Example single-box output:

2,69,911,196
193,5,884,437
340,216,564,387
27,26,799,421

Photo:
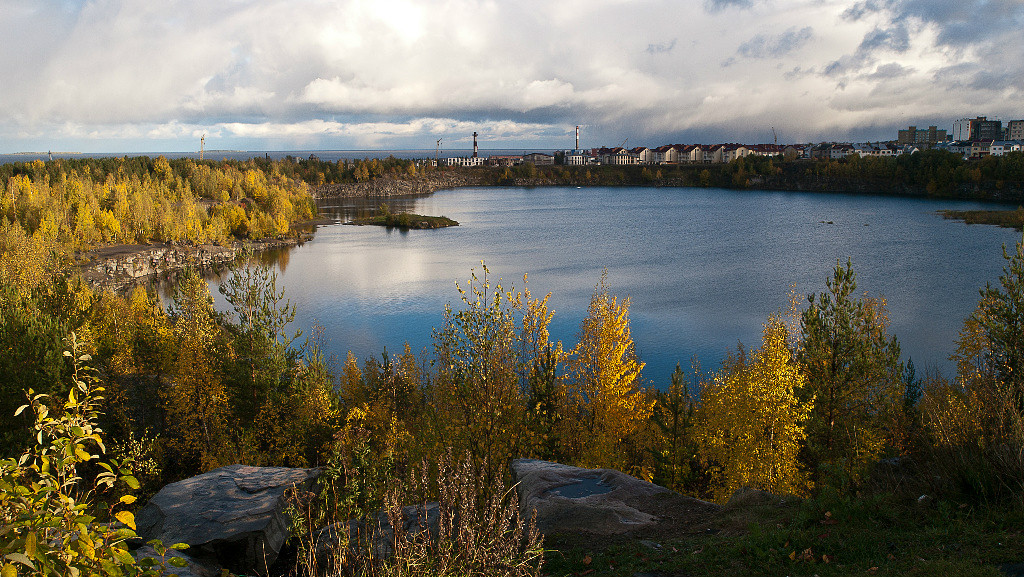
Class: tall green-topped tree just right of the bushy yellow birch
799,260,903,479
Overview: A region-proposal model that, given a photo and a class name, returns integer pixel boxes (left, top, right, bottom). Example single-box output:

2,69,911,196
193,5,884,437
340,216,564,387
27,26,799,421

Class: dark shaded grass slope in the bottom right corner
545,495,1024,577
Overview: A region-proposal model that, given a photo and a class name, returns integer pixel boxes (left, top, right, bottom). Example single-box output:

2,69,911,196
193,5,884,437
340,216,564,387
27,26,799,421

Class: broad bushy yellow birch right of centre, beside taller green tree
695,316,813,502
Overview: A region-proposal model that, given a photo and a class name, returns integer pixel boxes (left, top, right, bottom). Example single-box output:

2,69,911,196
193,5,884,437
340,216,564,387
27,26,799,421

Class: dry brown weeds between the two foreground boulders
296,454,544,577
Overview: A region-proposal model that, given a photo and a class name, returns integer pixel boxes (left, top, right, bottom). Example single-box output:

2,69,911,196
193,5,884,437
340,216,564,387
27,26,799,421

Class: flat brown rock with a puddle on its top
512,459,721,535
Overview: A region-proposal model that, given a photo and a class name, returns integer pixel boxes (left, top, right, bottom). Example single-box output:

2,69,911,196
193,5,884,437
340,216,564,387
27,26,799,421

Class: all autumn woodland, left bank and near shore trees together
0,159,1024,577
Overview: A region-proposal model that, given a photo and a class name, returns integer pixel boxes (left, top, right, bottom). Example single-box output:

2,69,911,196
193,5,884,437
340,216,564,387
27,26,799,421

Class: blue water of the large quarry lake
213,188,1021,387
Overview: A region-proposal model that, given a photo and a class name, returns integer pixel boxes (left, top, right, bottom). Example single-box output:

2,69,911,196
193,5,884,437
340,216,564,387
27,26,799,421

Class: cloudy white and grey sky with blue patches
0,0,1024,153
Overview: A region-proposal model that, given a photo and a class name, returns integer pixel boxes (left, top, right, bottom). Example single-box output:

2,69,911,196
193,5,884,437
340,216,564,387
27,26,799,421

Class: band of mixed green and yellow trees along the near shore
0,236,1024,510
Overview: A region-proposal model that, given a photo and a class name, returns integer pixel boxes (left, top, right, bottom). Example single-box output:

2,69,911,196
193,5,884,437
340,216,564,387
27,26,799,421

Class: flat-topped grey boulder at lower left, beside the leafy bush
135,465,319,575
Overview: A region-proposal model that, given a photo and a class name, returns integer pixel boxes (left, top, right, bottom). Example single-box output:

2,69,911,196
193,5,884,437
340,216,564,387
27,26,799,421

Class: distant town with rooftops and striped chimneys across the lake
434,116,1024,167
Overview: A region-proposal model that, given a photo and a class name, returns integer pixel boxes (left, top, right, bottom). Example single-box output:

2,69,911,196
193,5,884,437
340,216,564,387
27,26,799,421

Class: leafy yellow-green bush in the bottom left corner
0,333,184,577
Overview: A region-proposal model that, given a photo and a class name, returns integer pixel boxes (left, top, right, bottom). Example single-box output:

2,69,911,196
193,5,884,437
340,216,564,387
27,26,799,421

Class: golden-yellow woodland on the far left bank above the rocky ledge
0,157,315,249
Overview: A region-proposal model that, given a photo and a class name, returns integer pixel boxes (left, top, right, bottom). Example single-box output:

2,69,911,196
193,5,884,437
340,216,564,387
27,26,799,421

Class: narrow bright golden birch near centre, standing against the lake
562,271,654,479
